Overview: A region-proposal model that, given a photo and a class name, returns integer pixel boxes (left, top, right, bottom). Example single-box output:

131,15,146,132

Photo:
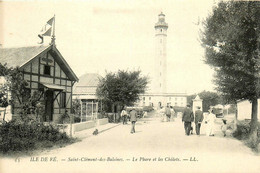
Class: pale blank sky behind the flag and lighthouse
0,0,215,94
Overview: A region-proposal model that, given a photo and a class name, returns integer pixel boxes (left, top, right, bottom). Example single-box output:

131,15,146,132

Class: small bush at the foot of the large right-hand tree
233,121,260,151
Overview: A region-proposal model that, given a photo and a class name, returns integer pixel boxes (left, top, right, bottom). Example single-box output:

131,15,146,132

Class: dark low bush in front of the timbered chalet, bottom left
0,120,71,153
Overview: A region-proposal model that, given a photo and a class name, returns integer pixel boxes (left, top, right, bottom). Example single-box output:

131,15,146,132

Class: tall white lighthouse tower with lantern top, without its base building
153,13,168,94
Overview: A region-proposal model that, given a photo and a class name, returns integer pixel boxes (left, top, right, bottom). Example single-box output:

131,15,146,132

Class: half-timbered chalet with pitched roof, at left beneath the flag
0,44,78,123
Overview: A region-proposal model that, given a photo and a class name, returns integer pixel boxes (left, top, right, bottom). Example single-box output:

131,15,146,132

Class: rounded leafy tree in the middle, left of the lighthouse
96,70,148,111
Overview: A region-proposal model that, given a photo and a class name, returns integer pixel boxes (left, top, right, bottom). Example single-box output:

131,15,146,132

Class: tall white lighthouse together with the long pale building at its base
138,13,187,109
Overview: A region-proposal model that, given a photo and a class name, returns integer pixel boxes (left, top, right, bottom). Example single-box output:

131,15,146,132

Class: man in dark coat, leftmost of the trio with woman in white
182,104,194,136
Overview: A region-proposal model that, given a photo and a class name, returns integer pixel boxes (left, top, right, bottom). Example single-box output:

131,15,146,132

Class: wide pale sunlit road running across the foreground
0,113,260,173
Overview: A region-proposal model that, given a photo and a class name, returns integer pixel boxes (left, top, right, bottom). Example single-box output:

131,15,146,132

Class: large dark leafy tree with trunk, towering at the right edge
202,1,260,140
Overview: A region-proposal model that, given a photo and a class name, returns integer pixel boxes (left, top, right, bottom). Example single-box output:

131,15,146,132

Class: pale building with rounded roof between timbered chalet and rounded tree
73,73,101,121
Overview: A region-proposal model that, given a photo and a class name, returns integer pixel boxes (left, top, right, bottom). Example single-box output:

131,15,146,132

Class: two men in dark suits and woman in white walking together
182,104,219,136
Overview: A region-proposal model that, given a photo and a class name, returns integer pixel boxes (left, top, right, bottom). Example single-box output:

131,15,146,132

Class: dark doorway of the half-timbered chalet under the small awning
44,90,53,121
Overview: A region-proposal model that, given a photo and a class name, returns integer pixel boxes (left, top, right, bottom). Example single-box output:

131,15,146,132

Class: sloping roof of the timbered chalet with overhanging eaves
0,44,78,81
